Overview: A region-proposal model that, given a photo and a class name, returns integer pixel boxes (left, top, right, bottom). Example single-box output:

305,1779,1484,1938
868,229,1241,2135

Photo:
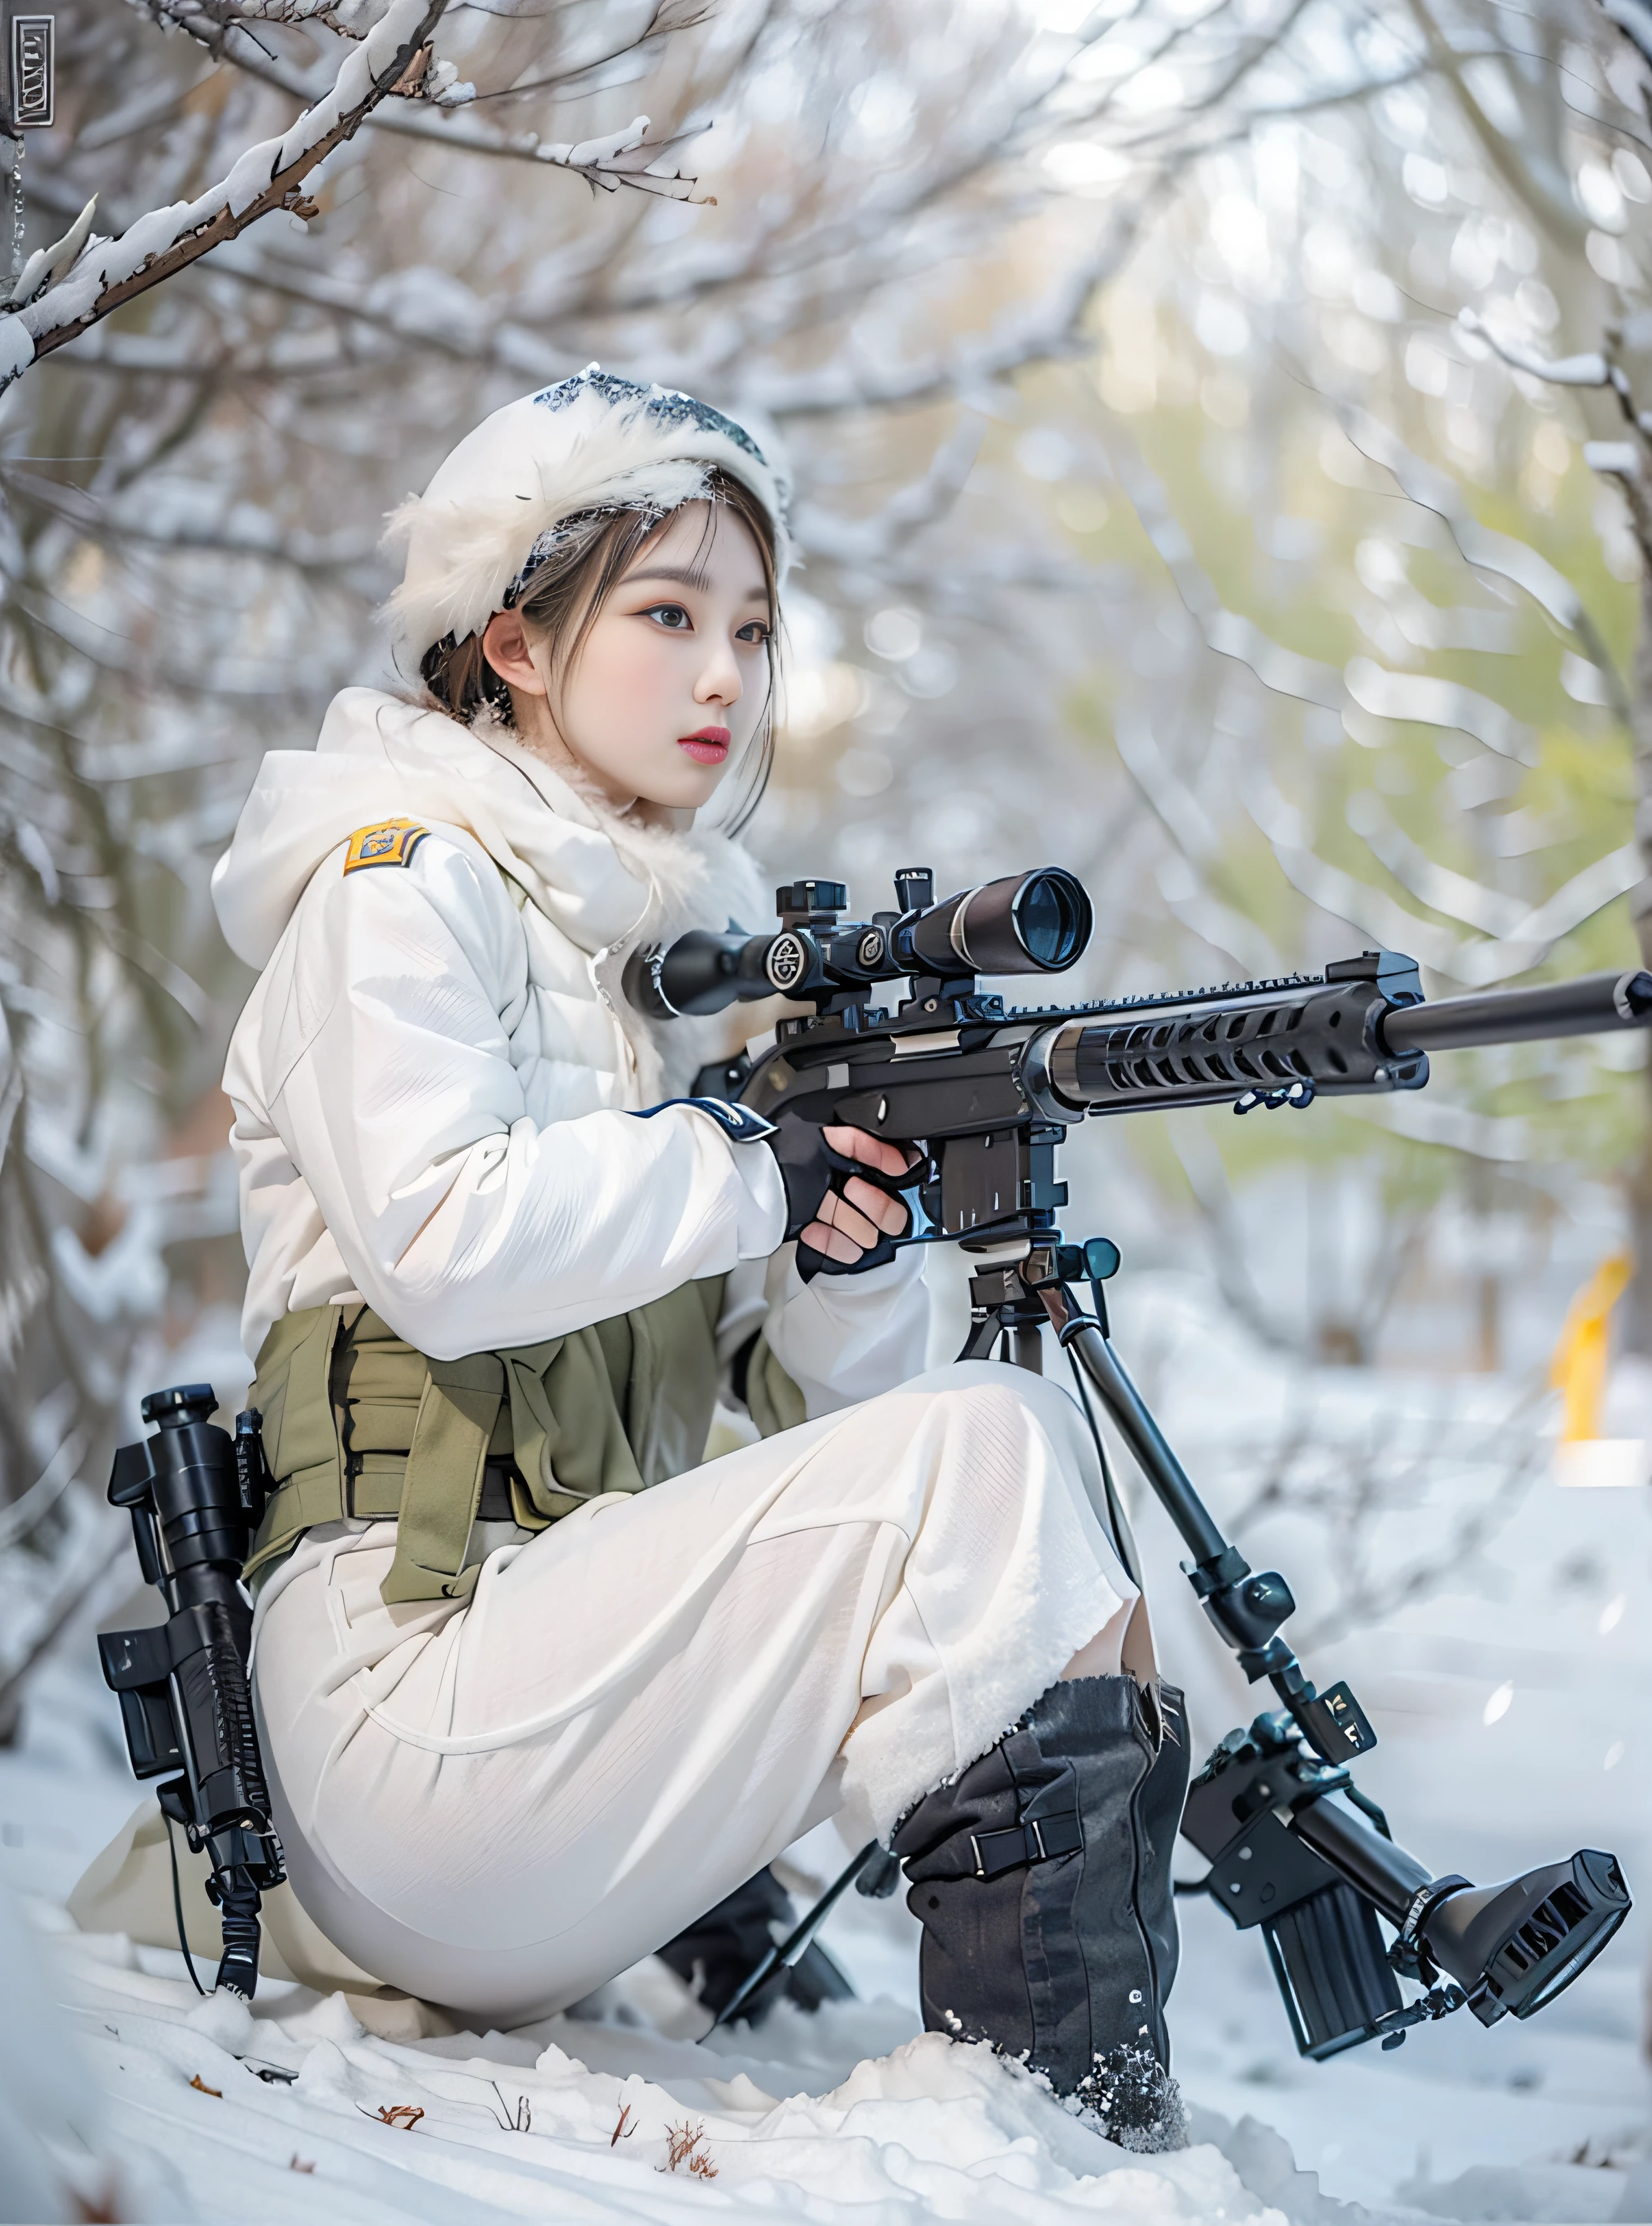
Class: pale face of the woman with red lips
483,503,770,811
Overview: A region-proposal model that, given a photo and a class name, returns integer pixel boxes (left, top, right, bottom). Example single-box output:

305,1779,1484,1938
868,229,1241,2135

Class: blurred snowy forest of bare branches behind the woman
0,0,1652,1737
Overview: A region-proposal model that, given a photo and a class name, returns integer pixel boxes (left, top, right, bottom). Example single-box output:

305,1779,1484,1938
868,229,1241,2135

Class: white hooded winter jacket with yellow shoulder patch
212,688,926,1415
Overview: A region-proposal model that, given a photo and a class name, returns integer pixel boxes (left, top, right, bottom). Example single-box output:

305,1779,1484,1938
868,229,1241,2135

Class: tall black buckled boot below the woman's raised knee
893,1676,1187,2148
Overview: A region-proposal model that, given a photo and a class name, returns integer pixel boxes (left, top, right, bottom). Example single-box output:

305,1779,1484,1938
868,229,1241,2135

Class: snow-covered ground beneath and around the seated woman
0,1284,1652,2226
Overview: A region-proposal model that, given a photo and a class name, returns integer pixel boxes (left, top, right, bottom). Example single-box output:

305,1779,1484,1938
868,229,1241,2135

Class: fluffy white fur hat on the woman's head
385,363,788,670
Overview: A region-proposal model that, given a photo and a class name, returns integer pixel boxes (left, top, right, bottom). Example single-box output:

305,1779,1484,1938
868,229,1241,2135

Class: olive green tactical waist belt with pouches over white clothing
243,1276,804,1602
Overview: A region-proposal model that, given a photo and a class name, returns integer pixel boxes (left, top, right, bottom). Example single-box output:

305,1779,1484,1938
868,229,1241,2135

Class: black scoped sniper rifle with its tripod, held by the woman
625,868,1652,2059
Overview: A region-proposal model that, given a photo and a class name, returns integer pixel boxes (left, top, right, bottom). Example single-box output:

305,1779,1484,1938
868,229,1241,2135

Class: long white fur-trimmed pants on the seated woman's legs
254,1362,1135,2025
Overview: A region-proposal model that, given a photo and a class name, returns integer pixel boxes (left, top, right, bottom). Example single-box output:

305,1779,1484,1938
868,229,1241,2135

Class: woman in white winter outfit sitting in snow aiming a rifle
214,367,1184,2119
